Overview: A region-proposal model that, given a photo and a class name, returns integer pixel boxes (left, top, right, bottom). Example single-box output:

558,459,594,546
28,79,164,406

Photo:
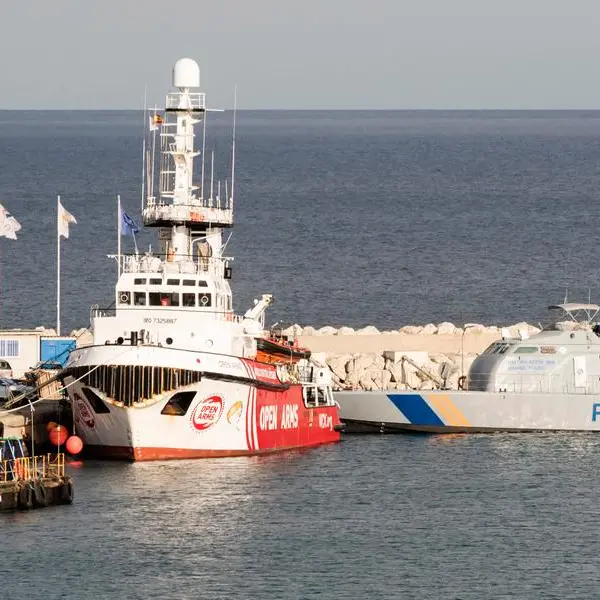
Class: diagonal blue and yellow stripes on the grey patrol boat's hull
388,394,471,427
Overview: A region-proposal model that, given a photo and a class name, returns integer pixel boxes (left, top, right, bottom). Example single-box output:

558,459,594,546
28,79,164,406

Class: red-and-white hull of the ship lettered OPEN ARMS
65,347,340,461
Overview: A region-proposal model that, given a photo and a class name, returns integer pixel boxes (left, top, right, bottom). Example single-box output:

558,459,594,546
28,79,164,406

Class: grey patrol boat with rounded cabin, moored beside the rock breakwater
334,303,600,433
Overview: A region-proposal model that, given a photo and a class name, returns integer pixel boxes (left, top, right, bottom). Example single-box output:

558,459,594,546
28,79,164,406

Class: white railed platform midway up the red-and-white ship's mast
142,200,233,225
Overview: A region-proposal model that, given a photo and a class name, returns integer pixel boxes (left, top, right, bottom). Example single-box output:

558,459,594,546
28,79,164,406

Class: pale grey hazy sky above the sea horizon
0,0,600,109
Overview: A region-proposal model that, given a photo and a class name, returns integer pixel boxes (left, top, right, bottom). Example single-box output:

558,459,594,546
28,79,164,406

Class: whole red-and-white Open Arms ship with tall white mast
62,58,341,460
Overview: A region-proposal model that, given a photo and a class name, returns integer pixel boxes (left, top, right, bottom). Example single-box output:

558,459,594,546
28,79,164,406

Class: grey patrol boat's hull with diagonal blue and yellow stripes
334,390,600,433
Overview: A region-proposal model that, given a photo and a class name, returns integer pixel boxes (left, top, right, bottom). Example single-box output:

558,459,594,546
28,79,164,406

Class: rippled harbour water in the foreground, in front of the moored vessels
0,434,600,600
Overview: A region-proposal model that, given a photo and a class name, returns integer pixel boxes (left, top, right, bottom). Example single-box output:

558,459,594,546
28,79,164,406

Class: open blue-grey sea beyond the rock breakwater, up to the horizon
0,111,600,332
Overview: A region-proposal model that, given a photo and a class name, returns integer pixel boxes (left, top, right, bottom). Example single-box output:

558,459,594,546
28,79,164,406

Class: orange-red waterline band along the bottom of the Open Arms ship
85,440,340,461
